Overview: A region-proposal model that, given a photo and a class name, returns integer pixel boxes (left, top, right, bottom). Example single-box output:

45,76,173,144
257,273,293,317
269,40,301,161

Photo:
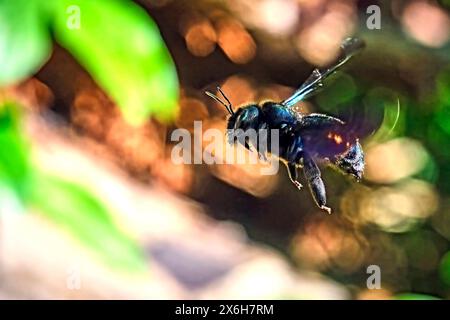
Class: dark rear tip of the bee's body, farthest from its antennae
332,140,364,181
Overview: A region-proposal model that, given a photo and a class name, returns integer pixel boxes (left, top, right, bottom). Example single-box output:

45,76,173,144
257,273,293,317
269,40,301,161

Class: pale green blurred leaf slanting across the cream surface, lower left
29,173,147,272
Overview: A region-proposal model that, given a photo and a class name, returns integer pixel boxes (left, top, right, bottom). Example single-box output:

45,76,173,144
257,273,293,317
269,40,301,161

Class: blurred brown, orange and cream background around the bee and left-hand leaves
0,0,450,299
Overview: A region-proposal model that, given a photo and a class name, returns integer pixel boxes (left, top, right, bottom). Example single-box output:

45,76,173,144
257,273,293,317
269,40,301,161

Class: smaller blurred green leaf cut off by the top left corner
0,0,51,86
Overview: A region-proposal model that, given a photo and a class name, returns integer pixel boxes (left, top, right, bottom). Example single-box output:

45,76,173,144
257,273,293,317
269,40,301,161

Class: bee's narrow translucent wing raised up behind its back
281,38,365,108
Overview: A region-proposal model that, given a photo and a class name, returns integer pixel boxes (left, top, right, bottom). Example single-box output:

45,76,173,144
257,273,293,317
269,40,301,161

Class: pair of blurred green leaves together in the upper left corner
0,0,178,124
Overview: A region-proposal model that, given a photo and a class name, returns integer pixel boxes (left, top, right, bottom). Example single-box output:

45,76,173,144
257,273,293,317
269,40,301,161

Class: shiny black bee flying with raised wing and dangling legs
206,38,364,213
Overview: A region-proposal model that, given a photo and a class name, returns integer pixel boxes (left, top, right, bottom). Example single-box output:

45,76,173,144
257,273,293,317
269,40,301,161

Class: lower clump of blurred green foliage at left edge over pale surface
0,103,146,272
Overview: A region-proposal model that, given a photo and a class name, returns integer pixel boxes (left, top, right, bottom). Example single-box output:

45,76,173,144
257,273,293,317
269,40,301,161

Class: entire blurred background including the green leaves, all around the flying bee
0,0,450,299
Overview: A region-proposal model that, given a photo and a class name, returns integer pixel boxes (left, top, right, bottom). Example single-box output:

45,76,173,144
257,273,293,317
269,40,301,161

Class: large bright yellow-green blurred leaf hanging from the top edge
47,0,178,124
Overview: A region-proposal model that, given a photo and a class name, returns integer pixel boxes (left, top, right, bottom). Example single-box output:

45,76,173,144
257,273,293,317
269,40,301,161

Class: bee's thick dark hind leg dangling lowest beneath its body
303,155,331,214
